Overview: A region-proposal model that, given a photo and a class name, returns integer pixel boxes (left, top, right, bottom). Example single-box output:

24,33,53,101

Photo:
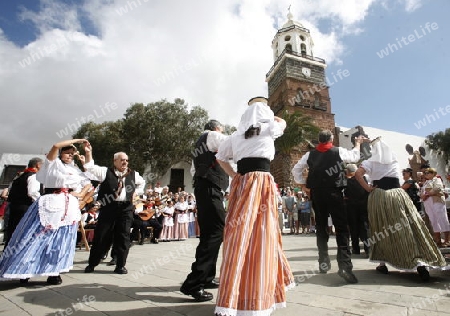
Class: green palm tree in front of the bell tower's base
275,110,320,186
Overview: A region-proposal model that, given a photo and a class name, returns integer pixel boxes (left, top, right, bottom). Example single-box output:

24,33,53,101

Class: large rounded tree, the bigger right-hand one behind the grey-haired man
123,99,208,183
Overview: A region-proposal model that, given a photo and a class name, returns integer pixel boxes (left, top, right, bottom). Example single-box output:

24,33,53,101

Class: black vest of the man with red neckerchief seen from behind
306,147,346,189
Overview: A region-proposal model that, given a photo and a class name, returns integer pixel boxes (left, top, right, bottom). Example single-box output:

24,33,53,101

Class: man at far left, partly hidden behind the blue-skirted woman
5,157,43,248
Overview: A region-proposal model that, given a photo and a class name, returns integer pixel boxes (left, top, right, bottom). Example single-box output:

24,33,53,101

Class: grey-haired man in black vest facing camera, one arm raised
84,143,145,274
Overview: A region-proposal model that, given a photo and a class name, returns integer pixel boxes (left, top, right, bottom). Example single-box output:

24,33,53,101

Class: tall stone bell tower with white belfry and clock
266,12,338,187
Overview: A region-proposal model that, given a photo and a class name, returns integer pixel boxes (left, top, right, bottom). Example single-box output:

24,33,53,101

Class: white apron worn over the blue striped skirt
38,193,81,229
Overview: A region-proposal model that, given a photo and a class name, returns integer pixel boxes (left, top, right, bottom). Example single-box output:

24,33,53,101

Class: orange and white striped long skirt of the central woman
215,171,295,316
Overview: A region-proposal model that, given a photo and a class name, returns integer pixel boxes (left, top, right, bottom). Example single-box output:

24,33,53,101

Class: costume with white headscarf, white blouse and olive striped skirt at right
361,140,446,271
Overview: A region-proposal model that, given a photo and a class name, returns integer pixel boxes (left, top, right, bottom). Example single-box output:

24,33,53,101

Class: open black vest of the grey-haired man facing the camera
97,168,136,205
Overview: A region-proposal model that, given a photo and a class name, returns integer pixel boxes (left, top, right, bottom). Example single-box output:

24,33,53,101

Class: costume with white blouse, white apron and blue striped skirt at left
0,158,90,279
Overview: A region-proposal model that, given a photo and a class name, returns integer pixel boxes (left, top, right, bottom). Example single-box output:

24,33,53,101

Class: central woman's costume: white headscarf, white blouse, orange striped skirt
215,102,295,316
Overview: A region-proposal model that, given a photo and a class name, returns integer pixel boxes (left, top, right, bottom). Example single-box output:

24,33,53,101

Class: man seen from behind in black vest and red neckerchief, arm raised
292,130,365,283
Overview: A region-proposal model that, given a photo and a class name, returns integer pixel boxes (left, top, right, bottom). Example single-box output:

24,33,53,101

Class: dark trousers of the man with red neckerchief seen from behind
311,188,353,271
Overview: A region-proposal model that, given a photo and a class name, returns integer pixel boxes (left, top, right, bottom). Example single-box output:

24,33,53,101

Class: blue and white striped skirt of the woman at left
0,200,78,280
